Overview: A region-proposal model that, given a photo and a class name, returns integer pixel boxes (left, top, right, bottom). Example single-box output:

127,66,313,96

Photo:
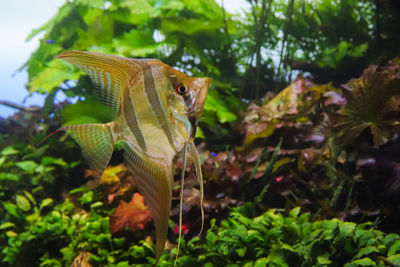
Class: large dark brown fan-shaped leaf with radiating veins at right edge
335,59,400,147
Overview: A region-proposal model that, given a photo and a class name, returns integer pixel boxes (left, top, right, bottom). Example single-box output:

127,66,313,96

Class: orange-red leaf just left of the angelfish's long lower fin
110,193,151,234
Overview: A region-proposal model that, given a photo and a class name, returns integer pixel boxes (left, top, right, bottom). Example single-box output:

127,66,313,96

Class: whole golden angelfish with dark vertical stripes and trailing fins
58,51,211,262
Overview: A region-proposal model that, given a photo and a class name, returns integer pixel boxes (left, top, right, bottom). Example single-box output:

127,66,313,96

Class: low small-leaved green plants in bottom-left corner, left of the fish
0,193,154,266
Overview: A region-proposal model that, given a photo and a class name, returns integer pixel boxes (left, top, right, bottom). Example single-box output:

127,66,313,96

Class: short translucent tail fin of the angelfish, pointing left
60,122,115,178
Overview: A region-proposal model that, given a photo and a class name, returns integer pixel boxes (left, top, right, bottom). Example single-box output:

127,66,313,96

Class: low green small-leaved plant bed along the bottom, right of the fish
178,203,400,266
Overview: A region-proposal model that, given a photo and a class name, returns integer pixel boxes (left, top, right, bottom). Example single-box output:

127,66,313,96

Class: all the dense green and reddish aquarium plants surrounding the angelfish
0,0,400,267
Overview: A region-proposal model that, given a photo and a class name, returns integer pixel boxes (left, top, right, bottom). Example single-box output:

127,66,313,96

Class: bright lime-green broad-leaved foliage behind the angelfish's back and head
26,0,240,138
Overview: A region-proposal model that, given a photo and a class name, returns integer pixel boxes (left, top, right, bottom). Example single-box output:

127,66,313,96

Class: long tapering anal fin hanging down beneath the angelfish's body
124,143,172,262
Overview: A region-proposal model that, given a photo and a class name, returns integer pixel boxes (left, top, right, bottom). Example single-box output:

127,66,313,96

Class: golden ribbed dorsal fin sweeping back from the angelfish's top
57,51,133,112
